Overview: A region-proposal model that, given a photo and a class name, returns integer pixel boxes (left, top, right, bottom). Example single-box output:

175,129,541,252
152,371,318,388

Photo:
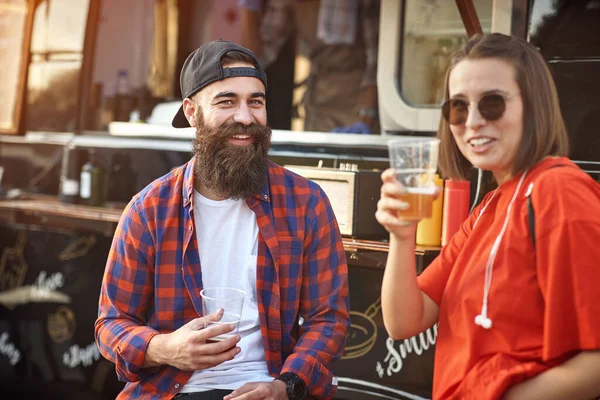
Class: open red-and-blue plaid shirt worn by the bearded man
95,158,350,399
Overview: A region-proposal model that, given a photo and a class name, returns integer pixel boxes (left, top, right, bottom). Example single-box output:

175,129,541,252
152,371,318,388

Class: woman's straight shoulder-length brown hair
437,33,569,179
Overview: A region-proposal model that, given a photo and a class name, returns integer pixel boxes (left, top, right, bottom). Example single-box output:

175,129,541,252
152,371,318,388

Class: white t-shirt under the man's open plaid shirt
181,190,273,393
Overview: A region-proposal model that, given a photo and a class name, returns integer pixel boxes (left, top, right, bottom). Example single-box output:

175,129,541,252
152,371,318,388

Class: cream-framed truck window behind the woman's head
377,0,504,135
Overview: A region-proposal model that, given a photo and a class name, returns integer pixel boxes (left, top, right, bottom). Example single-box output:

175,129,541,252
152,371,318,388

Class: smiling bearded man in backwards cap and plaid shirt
95,40,350,400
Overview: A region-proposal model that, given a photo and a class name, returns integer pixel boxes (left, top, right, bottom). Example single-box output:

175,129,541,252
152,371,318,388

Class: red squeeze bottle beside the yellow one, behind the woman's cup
442,179,471,246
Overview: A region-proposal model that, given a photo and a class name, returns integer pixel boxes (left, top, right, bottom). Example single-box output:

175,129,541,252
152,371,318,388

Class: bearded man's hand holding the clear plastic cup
144,314,240,371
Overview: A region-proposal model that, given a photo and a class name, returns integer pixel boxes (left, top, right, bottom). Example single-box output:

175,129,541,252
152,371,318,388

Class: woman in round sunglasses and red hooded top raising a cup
376,34,600,400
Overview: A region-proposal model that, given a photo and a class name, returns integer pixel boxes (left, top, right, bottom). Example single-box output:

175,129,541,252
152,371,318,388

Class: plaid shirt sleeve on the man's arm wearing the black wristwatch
282,189,350,399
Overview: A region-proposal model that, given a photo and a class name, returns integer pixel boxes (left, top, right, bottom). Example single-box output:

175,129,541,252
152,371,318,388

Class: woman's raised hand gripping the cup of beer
375,168,419,240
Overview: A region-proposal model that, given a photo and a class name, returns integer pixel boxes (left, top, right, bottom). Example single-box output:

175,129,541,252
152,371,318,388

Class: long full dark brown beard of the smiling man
193,108,271,199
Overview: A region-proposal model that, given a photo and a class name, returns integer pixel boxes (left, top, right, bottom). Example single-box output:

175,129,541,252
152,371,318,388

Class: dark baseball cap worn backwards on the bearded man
171,39,267,128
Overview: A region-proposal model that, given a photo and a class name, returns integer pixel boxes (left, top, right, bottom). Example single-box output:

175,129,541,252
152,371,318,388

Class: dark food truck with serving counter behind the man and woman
0,0,600,400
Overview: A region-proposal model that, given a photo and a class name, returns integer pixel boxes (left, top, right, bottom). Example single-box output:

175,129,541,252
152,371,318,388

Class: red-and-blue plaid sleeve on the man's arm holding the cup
95,199,158,382
